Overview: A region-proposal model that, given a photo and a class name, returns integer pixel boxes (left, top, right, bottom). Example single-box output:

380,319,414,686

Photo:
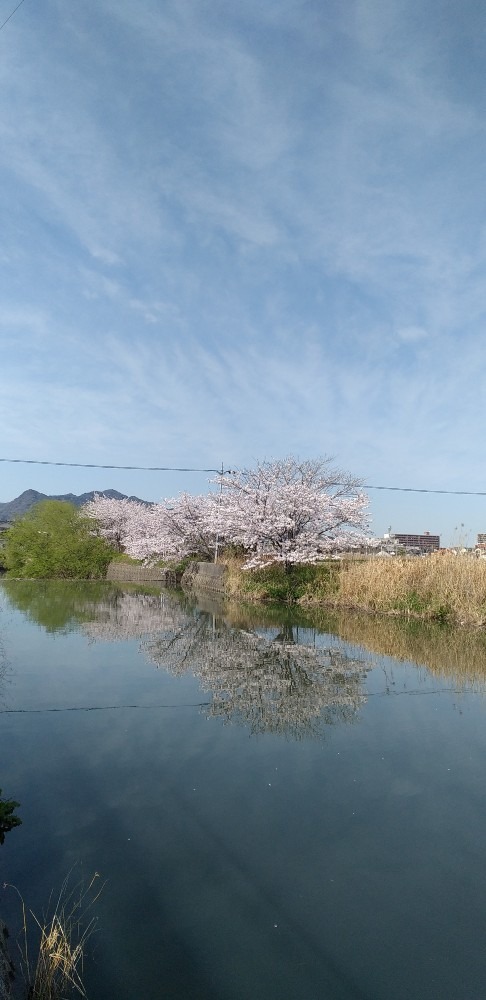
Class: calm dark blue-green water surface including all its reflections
0,581,486,1000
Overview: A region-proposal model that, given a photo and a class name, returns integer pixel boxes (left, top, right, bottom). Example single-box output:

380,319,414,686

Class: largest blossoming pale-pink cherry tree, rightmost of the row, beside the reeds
211,457,369,569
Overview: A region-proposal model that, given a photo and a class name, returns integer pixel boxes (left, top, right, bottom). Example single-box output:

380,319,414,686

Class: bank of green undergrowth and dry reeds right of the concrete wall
218,553,486,627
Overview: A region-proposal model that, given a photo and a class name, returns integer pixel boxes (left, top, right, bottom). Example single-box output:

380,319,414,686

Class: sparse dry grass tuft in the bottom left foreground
6,872,103,1000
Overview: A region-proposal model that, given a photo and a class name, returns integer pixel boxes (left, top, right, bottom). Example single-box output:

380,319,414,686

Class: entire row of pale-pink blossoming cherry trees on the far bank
84,458,370,569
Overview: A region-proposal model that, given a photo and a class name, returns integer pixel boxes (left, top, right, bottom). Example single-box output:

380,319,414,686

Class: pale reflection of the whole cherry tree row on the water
83,592,365,738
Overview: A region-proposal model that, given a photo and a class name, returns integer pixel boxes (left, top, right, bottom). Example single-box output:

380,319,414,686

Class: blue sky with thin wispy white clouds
0,0,486,543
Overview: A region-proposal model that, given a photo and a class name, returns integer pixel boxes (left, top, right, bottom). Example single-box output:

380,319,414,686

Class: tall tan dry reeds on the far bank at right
335,553,486,626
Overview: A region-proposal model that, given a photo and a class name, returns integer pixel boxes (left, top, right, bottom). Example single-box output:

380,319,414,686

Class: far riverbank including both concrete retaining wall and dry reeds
6,552,486,628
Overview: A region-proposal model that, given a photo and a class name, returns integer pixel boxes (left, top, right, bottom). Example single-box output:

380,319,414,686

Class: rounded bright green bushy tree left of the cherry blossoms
2,500,113,580
